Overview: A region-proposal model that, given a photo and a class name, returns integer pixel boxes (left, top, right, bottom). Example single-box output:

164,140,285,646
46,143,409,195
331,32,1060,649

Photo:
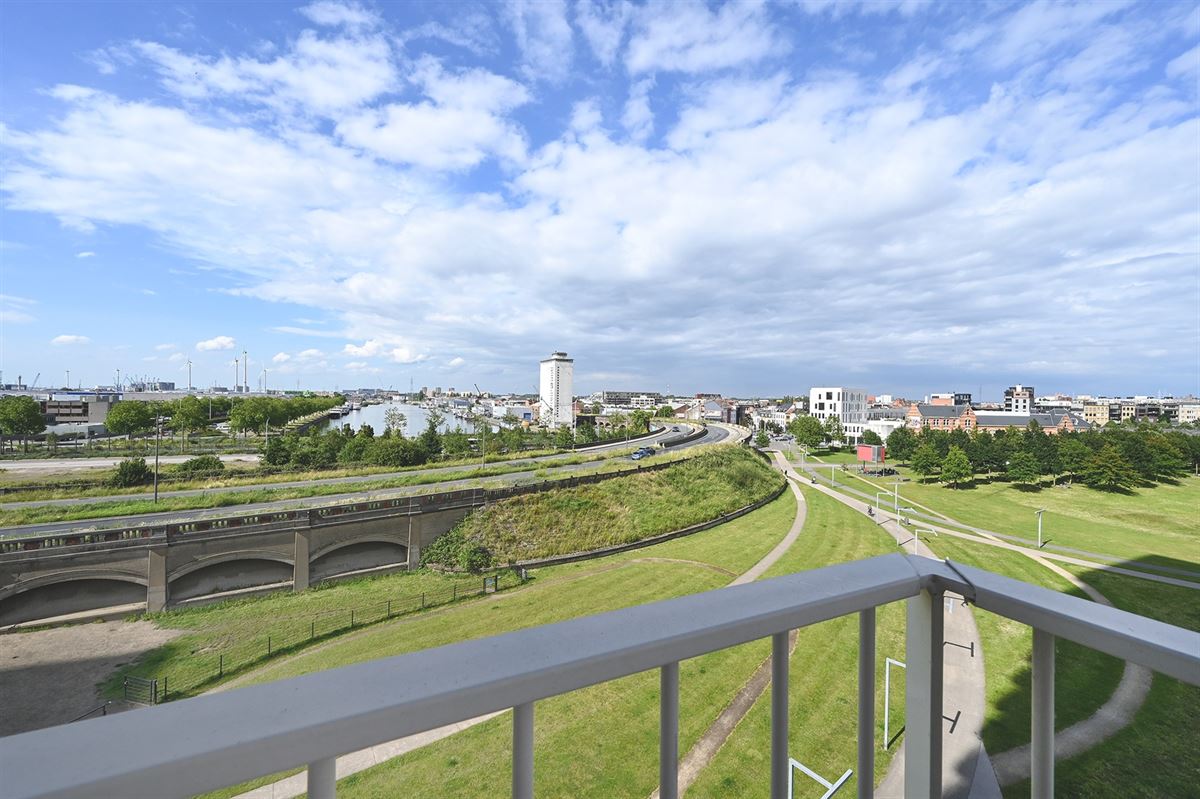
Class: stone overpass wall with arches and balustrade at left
0,453,696,627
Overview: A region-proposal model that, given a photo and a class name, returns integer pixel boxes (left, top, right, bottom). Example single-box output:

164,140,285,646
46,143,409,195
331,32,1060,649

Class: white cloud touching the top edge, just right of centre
625,2,790,74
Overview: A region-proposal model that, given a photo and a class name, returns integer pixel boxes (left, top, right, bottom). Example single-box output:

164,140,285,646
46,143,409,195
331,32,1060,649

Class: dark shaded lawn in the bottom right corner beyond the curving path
1004,565,1200,799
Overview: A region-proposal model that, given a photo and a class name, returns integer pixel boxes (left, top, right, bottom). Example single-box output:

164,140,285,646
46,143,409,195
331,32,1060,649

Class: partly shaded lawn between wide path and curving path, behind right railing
924,535,1124,753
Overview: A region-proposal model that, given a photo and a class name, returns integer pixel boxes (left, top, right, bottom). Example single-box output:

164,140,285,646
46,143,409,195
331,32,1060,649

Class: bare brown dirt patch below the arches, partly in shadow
0,621,180,735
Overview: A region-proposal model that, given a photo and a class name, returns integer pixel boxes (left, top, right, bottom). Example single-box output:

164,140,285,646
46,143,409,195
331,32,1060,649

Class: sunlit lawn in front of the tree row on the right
816,453,1200,572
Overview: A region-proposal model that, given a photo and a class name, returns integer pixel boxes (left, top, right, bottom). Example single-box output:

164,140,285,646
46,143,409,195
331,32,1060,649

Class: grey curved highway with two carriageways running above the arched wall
0,425,737,537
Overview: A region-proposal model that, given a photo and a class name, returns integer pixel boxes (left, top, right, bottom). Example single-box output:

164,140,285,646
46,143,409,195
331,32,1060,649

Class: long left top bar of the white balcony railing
0,554,920,799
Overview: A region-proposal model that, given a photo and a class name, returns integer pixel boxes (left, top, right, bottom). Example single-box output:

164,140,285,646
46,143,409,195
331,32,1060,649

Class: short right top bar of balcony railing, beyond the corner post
913,558,1200,685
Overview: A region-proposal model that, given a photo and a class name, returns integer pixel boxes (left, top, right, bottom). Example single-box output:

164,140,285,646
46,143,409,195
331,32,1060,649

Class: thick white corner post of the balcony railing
904,590,943,799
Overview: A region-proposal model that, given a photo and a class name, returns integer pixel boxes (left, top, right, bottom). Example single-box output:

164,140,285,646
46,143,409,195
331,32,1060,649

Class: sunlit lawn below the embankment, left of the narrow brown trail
196,492,796,799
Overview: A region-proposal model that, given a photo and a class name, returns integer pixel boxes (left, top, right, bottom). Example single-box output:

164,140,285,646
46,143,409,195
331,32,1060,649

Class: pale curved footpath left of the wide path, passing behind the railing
233,467,805,799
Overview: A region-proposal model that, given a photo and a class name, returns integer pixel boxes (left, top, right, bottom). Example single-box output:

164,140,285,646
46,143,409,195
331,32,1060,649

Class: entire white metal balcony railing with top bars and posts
0,554,1200,799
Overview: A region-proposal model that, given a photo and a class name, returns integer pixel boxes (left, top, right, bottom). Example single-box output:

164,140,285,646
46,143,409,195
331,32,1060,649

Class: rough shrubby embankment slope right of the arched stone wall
421,447,784,571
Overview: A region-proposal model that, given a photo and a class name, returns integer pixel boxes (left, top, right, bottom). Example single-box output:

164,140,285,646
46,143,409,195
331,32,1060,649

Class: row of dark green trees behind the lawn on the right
887,421,1200,491
